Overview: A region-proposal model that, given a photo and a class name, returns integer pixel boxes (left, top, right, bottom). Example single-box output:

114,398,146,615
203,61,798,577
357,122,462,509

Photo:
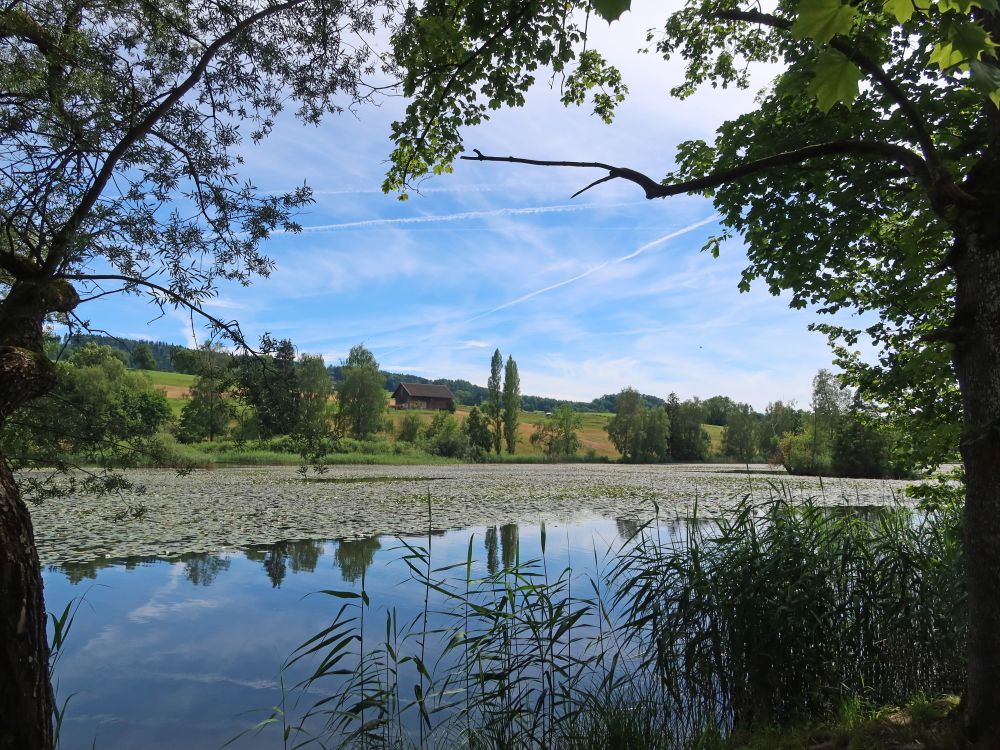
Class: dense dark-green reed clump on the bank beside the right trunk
612,493,965,732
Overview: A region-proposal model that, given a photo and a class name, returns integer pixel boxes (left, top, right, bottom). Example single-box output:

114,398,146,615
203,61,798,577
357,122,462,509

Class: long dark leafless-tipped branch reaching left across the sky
461,140,931,199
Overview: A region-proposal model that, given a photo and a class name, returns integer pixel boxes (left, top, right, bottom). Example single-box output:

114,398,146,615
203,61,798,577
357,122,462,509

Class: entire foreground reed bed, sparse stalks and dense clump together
252,492,965,750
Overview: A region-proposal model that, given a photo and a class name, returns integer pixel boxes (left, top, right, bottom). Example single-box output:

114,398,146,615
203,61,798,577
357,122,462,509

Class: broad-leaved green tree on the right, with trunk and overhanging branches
386,0,1000,748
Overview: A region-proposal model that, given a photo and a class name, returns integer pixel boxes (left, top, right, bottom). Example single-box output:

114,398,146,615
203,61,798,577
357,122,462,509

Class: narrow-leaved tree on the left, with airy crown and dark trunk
0,0,384,750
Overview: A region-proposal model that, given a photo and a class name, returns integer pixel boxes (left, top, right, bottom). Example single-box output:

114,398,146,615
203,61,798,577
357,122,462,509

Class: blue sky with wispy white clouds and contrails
72,0,868,410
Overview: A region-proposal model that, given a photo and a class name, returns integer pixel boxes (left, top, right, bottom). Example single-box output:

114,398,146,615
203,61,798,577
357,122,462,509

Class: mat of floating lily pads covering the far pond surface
31,464,920,564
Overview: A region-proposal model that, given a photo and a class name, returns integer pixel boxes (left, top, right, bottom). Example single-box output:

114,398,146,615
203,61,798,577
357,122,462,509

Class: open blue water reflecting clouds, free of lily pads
45,519,656,750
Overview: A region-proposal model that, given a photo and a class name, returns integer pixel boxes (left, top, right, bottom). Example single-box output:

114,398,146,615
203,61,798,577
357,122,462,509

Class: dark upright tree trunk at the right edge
952,214,1000,750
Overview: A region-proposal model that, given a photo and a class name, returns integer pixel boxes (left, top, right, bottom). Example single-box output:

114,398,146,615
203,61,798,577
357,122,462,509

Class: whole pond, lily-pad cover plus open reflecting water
39,466,916,750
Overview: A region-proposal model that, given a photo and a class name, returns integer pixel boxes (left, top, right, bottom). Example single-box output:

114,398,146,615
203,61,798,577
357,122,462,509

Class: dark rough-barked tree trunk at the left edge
0,281,79,750
